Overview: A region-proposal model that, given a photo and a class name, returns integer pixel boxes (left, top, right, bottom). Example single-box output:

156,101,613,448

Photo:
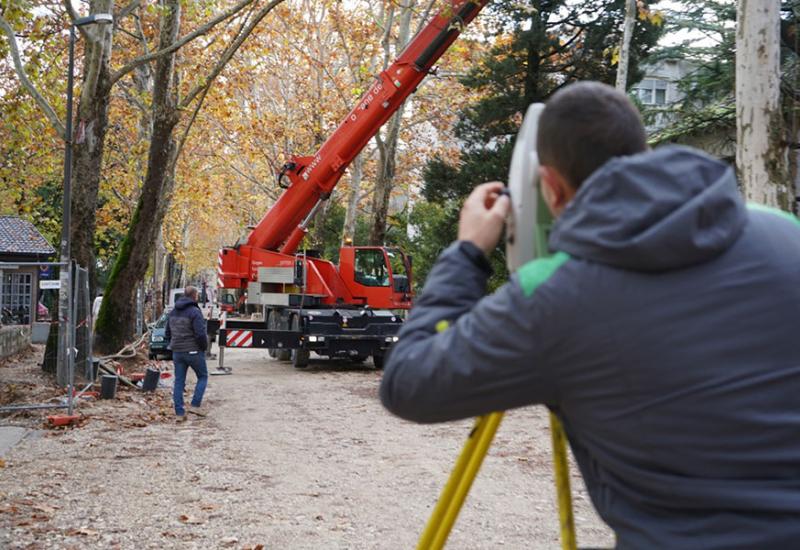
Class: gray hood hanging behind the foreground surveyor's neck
550,146,747,271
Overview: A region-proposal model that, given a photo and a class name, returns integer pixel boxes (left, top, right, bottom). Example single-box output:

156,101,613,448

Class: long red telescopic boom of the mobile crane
247,0,489,254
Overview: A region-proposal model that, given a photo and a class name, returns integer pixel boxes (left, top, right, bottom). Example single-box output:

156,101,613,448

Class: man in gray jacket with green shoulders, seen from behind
381,83,800,549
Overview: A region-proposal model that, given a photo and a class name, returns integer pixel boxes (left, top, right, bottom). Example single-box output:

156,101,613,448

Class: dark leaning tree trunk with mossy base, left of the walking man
95,0,181,352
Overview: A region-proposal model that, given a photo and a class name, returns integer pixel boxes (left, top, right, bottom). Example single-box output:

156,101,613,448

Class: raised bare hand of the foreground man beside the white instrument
458,181,511,256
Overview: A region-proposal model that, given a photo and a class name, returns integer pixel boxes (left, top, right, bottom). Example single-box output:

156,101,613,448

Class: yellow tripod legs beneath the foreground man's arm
417,412,577,550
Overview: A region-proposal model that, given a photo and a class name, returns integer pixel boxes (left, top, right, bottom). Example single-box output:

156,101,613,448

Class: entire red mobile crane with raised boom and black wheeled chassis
218,0,488,368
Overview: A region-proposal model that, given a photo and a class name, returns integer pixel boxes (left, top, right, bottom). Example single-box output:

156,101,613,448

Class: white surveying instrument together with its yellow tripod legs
417,103,576,550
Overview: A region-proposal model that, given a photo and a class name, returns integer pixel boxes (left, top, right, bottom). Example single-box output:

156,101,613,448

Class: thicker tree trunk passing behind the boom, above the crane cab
369,0,414,246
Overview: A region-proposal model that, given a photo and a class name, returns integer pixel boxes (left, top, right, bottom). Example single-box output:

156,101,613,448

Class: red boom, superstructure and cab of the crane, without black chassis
218,0,488,309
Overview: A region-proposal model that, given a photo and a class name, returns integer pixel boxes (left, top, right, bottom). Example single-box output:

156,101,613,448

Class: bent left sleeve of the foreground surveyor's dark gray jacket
380,245,555,422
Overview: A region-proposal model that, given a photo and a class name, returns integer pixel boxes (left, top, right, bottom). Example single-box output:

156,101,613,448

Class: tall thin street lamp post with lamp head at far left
56,13,114,398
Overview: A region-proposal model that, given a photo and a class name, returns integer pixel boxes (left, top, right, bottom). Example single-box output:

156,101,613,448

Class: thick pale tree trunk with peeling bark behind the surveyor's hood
736,0,794,211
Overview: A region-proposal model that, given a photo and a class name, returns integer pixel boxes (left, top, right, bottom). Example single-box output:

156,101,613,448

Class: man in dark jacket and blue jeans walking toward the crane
166,286,208,422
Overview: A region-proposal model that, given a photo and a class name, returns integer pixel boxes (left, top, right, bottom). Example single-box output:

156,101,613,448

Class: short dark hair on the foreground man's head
536,82,647,189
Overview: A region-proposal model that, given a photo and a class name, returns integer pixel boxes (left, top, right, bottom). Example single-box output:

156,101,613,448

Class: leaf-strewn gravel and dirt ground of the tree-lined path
0,350,613,550
